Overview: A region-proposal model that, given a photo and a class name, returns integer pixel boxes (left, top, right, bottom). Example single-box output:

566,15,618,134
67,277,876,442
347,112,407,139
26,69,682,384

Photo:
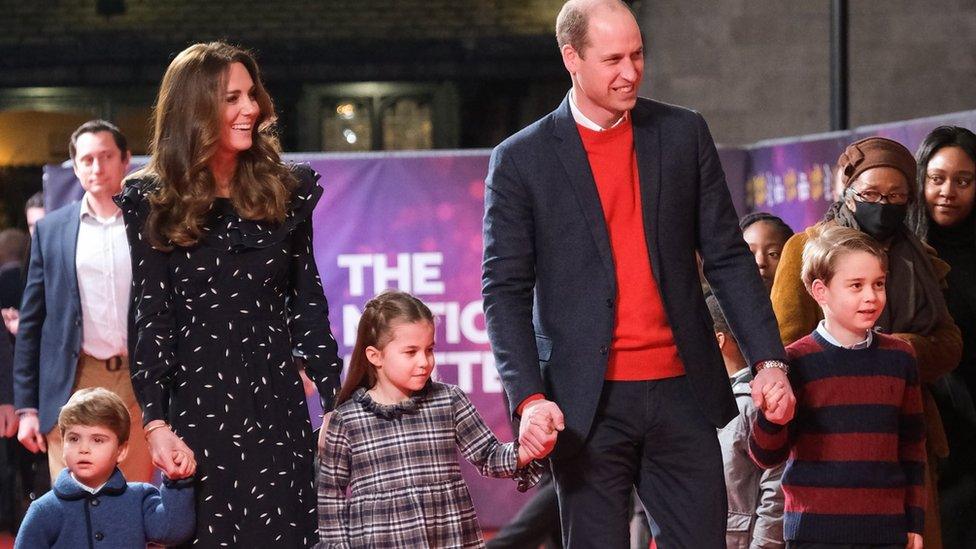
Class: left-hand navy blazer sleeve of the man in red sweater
481,146,545,410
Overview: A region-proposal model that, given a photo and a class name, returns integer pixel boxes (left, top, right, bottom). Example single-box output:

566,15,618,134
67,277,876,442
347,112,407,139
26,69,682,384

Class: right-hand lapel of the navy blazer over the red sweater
631,99,662,288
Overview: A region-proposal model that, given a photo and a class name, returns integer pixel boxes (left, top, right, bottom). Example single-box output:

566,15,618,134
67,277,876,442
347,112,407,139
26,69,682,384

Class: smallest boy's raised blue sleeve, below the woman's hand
142,478,196,545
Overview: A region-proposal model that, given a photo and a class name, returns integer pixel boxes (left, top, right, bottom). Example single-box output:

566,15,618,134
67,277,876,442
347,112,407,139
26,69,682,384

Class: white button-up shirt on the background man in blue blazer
75,193,132,360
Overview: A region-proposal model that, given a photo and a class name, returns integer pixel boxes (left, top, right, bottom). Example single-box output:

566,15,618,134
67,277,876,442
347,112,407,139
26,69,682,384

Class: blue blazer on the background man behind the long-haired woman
14,202,81,433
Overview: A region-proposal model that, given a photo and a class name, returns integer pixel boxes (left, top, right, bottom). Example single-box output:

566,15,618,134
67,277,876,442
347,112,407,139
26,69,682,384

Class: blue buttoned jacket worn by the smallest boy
14,469,195,549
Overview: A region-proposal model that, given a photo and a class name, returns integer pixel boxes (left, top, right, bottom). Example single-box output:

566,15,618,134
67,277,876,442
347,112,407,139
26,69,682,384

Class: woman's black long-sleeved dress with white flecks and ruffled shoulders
116,166,341,548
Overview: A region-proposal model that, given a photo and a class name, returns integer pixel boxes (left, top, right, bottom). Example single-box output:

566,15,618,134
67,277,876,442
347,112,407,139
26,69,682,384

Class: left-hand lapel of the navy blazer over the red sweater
553,94,616,290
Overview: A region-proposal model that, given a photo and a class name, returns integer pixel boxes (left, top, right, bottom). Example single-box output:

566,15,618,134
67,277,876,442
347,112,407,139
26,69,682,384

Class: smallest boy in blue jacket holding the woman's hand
14,387,196,549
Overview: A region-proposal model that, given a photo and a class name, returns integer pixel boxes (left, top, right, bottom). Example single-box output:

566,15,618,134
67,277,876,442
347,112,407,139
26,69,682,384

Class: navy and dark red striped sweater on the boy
749,332,925,544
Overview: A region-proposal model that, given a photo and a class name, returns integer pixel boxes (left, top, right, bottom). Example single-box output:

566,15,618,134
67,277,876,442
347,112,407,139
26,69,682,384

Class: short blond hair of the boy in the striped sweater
800,224,888,292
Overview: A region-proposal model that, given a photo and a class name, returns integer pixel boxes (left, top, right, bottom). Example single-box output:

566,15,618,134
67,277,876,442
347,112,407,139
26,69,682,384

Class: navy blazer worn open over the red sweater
482,95,786,459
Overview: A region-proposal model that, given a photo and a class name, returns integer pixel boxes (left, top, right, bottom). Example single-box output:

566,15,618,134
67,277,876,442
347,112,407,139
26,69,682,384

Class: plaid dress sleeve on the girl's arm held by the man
451,386,543,492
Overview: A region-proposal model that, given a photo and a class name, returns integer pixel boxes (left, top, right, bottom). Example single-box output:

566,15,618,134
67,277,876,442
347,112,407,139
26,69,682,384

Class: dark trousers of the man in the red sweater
553,376,728,549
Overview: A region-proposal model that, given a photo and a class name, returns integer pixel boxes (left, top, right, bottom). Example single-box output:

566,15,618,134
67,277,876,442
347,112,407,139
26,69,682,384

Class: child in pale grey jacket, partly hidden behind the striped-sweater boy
705,295,783,549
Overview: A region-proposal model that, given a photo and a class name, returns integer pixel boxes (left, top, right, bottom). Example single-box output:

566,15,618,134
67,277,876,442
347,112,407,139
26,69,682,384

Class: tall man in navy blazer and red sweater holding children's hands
482,0,795,549
